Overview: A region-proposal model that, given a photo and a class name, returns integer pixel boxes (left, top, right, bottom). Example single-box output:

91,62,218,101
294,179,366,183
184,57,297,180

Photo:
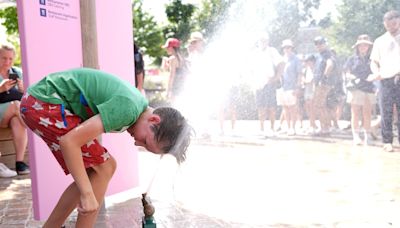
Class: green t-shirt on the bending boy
28,68,148,132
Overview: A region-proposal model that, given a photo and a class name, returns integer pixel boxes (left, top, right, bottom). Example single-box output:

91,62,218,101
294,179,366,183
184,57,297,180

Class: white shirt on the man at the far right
370,32,400,78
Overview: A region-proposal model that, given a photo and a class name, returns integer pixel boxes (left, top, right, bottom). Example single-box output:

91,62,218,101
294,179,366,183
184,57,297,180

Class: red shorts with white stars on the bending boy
20,94,110,175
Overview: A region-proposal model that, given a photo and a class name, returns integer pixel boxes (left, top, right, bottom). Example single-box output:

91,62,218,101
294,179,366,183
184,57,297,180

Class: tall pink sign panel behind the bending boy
17,0,138,220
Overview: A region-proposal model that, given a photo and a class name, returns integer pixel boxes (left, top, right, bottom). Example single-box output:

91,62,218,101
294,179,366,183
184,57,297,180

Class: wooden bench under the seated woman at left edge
0,128,28,170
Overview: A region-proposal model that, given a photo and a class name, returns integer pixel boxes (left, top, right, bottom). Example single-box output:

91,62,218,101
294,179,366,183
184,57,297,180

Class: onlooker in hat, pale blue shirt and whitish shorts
279,40,302,136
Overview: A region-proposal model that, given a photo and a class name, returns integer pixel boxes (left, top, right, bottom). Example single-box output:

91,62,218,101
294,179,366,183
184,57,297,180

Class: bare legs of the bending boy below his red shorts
43,157,116,228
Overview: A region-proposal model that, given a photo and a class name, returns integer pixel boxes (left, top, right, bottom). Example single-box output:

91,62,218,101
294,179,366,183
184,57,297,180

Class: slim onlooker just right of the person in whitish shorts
302,55,317,134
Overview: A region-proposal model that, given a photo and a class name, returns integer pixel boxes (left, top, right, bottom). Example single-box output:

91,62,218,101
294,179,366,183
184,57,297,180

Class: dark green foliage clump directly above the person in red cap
163,0,196,41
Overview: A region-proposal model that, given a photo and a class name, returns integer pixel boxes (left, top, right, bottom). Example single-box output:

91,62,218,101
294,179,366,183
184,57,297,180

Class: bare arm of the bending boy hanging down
60,115,104,214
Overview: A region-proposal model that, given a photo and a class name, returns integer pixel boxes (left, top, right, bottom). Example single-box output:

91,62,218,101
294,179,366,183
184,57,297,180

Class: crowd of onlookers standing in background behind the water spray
159,10,400,151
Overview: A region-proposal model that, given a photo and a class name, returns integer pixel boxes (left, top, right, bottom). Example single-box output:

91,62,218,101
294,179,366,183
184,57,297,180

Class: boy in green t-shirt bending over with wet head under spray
21,68,191,227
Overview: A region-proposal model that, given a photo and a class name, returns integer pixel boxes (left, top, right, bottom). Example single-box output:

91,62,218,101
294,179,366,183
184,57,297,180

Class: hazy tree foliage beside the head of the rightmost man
326,0,400,55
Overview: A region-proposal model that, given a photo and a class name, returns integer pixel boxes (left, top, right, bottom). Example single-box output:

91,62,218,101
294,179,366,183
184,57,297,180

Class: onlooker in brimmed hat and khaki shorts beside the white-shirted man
344,34,377,145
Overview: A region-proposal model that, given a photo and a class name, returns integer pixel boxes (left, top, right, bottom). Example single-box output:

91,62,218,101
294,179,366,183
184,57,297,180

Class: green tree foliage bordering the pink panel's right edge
133,0,164,62
